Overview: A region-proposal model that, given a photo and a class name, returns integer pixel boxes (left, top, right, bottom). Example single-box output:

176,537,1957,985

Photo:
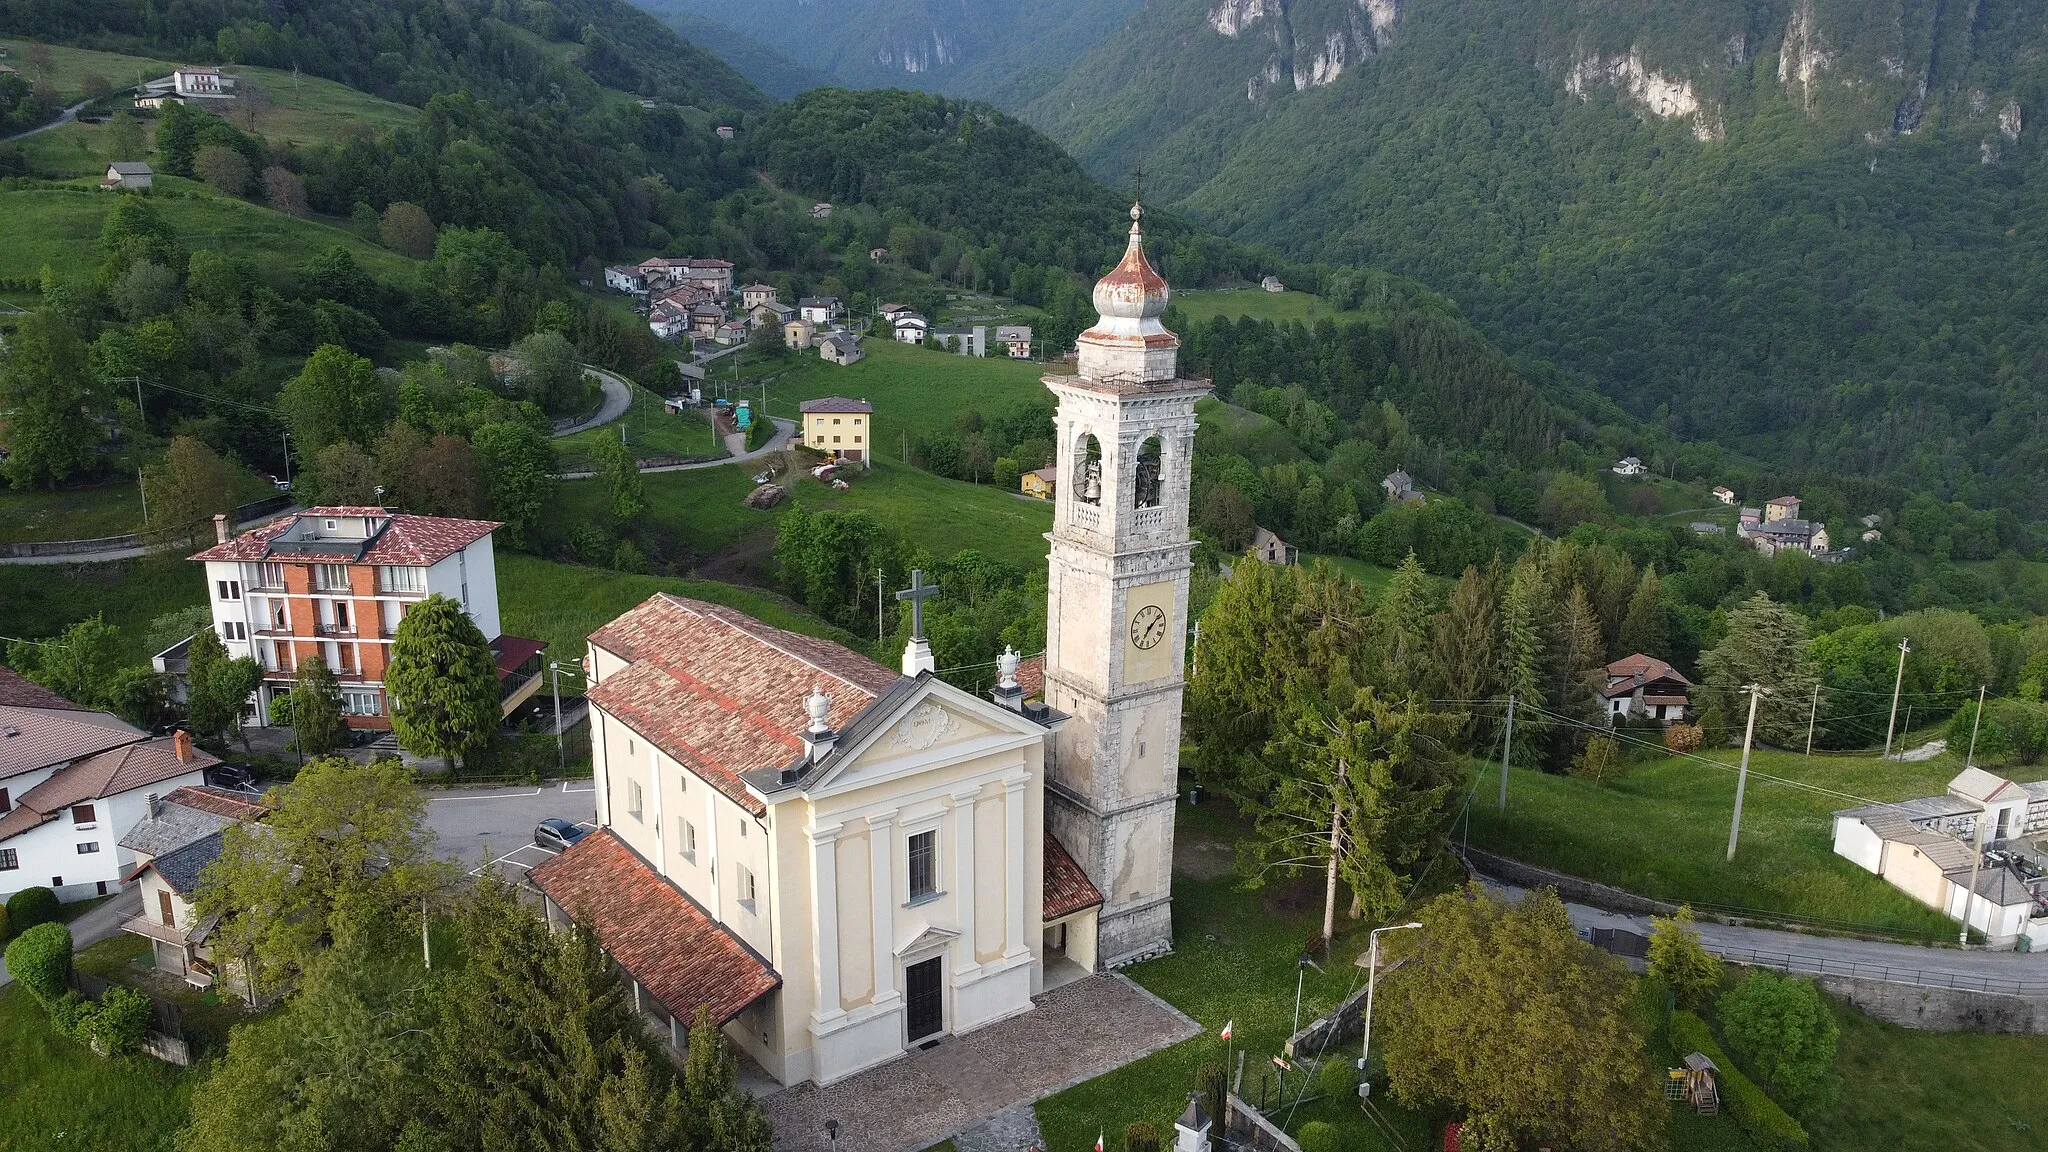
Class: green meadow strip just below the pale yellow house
549,453,1053,572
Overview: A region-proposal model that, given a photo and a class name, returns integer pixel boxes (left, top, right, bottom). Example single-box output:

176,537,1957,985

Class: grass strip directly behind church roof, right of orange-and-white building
498,551,860,664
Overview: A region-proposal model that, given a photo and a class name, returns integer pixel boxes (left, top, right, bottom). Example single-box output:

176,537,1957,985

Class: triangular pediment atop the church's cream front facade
807,678,1049,795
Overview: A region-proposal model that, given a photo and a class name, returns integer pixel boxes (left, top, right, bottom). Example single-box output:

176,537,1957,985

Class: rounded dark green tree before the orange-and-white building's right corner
385,592,500,769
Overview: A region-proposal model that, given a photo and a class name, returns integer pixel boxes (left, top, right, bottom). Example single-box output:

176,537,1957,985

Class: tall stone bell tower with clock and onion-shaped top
1044,205,1208,965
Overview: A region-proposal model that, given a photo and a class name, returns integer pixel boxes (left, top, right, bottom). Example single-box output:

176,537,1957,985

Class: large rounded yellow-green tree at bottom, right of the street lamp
1374,886,1665,1152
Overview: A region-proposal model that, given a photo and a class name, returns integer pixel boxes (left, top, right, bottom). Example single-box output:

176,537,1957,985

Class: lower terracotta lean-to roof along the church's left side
526,828,782,1025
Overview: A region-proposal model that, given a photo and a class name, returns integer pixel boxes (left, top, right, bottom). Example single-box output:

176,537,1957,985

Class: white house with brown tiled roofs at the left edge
0,668,219,902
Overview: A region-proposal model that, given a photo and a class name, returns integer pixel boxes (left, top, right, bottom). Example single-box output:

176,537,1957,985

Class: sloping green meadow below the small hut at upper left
0,176,414,283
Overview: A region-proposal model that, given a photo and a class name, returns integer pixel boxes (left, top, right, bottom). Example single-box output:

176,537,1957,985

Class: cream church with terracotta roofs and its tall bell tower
530,207,1208,1084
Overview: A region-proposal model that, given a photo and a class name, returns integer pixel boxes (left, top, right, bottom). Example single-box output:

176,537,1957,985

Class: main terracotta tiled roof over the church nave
588,592,897,816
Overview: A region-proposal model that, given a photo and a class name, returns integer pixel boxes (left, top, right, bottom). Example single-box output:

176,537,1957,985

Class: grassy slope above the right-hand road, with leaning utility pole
1470,748,1998,939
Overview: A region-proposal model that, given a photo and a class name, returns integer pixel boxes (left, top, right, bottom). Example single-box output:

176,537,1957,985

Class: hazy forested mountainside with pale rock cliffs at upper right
1026,0,2048,517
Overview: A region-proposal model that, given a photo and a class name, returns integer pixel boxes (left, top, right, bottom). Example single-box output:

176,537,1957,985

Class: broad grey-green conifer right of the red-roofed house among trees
1700,592,1817,748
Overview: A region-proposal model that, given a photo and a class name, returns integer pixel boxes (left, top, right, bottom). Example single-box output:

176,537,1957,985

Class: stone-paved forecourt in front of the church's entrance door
762,974,1200,1152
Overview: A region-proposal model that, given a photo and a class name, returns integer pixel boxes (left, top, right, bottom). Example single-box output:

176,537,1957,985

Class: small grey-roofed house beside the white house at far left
121,785,270,988
